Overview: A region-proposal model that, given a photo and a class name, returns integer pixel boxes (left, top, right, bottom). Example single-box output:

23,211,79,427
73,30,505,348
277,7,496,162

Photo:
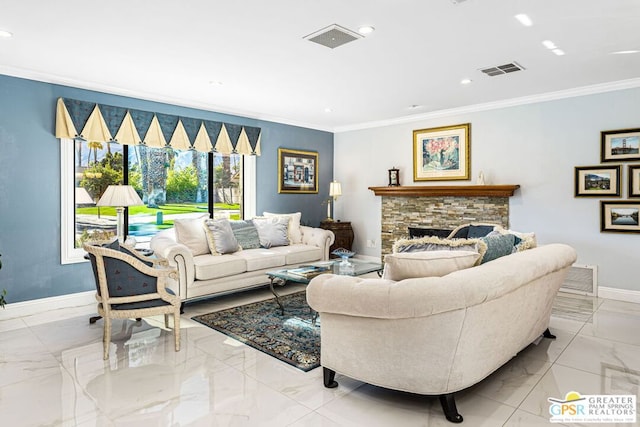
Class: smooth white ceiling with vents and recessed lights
0,0,640,131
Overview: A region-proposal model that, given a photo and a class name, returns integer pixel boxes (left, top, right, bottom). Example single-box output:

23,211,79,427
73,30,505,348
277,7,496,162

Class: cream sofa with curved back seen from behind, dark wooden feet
307,244,576,422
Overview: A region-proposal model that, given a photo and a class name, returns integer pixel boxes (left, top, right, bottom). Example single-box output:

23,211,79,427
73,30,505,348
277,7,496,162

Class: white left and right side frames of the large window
60,138,257,265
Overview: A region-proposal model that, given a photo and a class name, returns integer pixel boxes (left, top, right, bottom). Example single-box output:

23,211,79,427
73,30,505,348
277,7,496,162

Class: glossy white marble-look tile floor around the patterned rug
0,285,640,427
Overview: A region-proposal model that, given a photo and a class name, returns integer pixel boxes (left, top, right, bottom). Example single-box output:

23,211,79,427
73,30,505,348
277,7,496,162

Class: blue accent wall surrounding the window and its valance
0,75,333,303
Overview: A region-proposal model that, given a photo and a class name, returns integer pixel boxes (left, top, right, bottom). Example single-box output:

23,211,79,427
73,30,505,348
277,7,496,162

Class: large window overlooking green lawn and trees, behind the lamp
61,139,256,264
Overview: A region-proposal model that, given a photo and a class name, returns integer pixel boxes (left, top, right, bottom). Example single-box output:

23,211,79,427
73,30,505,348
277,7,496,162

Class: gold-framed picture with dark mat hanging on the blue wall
278,148,318,193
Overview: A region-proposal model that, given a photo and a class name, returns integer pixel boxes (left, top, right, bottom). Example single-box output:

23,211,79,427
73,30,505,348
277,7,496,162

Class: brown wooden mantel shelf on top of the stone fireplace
369,185,520,197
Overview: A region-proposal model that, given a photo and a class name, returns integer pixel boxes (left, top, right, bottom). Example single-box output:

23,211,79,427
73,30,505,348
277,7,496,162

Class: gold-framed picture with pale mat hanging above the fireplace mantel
413,123,471,181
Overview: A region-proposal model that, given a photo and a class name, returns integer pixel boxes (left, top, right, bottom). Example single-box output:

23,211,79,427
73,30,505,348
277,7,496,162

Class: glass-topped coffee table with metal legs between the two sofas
266,258,384,315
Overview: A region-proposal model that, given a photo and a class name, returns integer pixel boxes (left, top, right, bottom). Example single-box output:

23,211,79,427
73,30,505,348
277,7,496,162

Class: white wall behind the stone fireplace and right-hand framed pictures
334,88,640,291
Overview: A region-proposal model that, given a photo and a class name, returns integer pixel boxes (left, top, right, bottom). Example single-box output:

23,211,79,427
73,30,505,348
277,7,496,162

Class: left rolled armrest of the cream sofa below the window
149,229,195,300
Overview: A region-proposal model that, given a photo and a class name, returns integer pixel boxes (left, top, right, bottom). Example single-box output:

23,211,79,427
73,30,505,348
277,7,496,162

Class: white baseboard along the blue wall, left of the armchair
0,291,96,320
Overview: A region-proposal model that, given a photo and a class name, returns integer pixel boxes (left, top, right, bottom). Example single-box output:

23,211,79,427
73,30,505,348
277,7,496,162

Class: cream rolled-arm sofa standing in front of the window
150,215,335,302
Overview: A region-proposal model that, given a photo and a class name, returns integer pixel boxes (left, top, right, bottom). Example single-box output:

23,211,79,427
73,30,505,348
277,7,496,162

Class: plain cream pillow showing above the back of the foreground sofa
382,251,480,281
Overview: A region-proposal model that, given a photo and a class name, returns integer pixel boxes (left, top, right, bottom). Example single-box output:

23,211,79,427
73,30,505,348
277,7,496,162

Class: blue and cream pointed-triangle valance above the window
56,98,260,155
